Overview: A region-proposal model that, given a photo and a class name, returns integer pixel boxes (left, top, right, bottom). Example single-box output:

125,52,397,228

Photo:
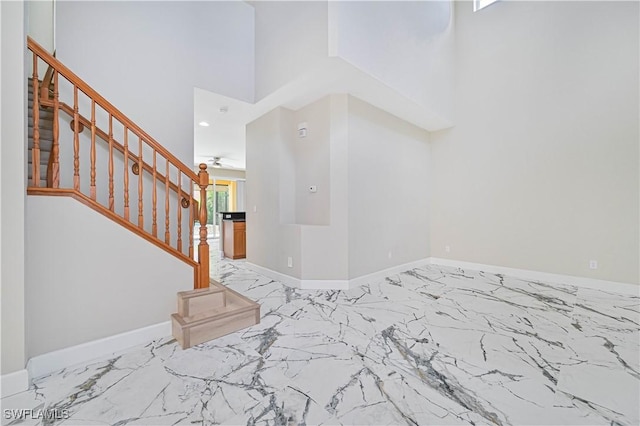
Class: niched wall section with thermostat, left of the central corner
246,95,348,280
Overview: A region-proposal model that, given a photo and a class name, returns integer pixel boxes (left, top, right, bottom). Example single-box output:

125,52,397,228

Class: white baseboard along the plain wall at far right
428,257,640,296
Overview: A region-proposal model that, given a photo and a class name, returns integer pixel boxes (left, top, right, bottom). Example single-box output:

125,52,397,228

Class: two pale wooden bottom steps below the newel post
171,280,260,349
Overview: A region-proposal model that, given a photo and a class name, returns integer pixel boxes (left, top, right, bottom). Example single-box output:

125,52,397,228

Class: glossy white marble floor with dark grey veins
2,261,640,425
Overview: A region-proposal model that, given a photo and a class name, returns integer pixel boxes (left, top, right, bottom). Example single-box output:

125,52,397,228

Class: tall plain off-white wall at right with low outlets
431,2,640,283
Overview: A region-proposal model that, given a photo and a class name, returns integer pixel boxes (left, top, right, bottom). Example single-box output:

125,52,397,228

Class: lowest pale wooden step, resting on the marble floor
171,282,260,349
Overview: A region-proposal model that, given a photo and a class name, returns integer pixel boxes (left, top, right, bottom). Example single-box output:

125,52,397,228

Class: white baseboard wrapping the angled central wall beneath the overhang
245,258,429,290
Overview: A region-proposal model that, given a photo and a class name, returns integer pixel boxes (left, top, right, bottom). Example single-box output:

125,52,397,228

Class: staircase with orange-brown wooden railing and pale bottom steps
27,38,260,349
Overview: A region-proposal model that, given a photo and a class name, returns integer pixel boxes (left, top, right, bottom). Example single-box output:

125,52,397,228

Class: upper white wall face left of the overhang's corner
252,1,328,101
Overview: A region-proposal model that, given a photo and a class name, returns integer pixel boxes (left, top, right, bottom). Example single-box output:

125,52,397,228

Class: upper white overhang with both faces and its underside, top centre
251,1,454,129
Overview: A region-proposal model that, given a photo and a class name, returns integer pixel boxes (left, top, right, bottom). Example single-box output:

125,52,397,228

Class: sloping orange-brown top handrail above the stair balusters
27,36,199,182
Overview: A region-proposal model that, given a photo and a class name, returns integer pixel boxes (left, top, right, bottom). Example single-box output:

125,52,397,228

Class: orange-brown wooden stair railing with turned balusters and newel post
27,37,209,288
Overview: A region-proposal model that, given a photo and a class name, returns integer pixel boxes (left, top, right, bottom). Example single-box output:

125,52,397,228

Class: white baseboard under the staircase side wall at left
27,321,171,379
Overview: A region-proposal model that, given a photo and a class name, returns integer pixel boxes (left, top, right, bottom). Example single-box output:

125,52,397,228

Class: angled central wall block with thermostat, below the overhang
247,95,430,282
